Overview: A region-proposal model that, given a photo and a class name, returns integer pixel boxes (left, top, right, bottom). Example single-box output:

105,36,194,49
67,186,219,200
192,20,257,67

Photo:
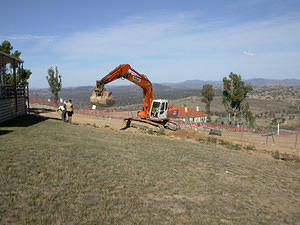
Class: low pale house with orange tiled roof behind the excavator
170,106,207,123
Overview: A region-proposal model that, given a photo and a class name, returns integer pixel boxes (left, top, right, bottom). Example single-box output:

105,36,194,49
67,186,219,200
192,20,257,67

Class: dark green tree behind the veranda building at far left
0,40,32,84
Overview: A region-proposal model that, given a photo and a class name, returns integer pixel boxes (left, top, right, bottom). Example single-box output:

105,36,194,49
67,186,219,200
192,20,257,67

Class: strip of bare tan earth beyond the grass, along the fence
31,99,299,160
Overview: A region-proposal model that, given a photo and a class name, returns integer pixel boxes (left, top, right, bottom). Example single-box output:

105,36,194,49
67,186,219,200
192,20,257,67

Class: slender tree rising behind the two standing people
46,66,62,101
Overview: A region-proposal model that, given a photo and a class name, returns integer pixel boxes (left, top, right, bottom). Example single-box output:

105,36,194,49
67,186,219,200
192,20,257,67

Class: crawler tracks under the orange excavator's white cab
121,118,180,132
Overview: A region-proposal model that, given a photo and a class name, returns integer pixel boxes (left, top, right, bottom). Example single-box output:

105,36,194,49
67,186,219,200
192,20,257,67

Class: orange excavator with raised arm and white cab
90,64,180,130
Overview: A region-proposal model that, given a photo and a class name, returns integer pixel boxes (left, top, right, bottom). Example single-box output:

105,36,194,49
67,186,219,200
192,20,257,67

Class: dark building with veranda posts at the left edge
0,51,29,123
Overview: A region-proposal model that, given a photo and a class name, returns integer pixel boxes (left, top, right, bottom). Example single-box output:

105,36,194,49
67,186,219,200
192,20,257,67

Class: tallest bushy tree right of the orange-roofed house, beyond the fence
223,72,253,121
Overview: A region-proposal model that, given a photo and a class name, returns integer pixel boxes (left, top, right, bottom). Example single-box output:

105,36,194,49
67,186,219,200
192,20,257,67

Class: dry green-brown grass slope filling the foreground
0,115,300,224
